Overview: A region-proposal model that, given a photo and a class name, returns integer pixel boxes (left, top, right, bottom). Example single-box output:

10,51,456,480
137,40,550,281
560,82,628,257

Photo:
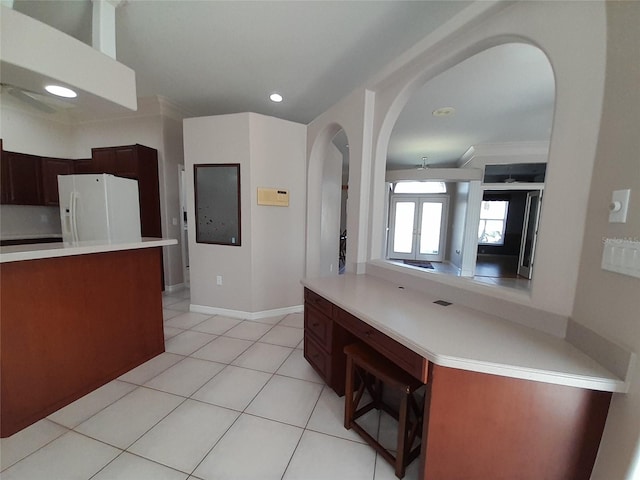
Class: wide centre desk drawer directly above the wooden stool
335,307,429,383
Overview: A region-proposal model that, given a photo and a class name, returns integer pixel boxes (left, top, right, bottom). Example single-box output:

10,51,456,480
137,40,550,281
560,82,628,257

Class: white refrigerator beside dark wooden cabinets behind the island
58,173,142,243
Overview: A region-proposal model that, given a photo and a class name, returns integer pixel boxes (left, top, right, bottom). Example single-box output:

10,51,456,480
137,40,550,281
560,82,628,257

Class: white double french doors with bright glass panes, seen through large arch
387,195,449,262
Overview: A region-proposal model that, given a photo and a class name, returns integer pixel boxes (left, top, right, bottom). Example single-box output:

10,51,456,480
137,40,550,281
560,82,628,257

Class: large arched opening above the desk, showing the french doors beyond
374,43,555,288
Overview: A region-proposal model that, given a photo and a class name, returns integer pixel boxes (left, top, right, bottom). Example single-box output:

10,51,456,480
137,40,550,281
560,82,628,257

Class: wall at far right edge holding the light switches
573,2,640,480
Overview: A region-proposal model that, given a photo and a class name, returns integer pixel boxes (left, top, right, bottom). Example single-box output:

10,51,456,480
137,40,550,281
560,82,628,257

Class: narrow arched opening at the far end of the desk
306,124,349,277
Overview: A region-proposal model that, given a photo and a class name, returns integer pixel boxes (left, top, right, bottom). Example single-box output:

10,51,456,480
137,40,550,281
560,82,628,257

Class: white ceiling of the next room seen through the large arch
387,44,555,169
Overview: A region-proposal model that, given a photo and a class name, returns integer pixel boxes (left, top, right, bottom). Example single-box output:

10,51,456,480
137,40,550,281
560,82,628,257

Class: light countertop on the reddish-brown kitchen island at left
0,238,178,263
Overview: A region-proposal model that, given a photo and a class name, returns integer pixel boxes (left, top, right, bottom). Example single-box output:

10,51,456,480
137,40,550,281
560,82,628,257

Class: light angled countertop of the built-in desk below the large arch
302,274,628,392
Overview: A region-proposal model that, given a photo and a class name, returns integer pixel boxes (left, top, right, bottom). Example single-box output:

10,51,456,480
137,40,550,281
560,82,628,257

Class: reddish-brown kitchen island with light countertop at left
0,238,177,438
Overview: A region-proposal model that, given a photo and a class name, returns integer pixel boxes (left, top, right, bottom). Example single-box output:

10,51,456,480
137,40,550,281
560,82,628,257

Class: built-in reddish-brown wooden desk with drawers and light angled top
303,274,627,480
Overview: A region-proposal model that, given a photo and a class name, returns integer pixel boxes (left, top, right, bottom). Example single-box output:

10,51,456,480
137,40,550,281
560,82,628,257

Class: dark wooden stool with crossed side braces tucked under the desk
344,343,424,478
